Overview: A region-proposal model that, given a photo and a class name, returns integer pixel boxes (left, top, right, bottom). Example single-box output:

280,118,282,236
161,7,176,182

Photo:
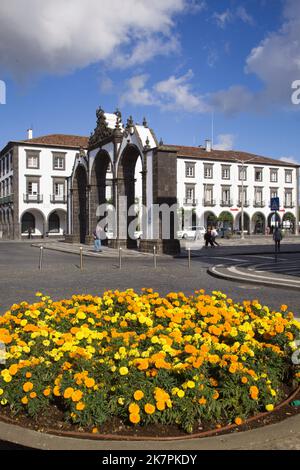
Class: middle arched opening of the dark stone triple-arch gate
90,151,115,241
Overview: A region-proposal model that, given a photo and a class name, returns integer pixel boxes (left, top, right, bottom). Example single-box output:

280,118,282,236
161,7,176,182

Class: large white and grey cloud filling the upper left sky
0,0,188,78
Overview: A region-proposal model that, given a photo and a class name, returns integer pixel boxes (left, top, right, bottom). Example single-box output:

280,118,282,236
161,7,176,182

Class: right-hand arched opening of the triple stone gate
117,145,143,248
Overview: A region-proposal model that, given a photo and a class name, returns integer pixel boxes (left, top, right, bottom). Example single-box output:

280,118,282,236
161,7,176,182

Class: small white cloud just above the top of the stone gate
121,70,210,113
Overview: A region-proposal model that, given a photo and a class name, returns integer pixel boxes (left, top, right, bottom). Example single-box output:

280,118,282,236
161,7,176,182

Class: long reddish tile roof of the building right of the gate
160,145,300,167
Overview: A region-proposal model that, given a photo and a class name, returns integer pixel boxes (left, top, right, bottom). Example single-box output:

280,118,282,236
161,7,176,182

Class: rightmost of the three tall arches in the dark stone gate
116,145,145,248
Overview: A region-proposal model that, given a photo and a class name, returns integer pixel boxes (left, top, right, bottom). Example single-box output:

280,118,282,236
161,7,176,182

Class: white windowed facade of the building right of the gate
177,155,298,234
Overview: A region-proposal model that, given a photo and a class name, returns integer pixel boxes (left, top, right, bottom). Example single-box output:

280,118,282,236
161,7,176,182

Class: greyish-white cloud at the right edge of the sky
212,0,300,113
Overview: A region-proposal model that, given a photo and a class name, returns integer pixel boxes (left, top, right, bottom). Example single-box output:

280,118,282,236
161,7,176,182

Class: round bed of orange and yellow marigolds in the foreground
0,289,300,432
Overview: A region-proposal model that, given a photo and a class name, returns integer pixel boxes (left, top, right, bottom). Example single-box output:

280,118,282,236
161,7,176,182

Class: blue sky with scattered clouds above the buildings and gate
0,0,300,163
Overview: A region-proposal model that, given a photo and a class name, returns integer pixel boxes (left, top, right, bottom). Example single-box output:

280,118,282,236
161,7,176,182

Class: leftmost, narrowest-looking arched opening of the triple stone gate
73,165,88,243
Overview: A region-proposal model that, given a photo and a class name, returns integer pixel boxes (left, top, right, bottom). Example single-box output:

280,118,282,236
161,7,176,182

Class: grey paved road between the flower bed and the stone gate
0,242,300,316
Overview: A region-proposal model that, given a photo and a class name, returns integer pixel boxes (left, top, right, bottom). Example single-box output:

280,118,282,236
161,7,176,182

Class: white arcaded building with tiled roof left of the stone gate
0,130,88,239
